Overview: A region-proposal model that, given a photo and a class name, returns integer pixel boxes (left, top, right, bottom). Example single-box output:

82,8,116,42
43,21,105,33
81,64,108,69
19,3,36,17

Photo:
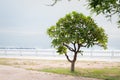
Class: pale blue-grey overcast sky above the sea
0,0,120,50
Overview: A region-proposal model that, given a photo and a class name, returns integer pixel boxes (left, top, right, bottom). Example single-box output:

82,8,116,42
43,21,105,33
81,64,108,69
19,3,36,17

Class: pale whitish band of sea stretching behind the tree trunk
0,48,120,62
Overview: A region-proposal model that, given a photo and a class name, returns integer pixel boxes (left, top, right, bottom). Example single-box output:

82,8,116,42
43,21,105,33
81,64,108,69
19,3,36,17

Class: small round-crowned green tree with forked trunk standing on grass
47,11,107,72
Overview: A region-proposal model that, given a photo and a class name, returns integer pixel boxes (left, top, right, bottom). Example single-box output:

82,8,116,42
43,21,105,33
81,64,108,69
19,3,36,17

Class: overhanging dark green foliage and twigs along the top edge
48,0,120,27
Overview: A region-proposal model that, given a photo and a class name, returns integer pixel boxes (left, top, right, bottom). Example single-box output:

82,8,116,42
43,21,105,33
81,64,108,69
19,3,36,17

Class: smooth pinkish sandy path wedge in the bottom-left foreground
0,65,100,80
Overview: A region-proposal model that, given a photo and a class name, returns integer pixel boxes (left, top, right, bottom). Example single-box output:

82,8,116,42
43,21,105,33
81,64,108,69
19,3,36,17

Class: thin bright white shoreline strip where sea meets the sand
0,56,120,62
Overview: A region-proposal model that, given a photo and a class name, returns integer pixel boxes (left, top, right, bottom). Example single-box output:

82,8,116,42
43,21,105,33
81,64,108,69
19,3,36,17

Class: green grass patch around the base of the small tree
39,68,120,80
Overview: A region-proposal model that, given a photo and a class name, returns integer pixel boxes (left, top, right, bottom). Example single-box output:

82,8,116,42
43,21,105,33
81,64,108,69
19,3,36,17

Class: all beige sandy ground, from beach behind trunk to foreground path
0,59,120,80
